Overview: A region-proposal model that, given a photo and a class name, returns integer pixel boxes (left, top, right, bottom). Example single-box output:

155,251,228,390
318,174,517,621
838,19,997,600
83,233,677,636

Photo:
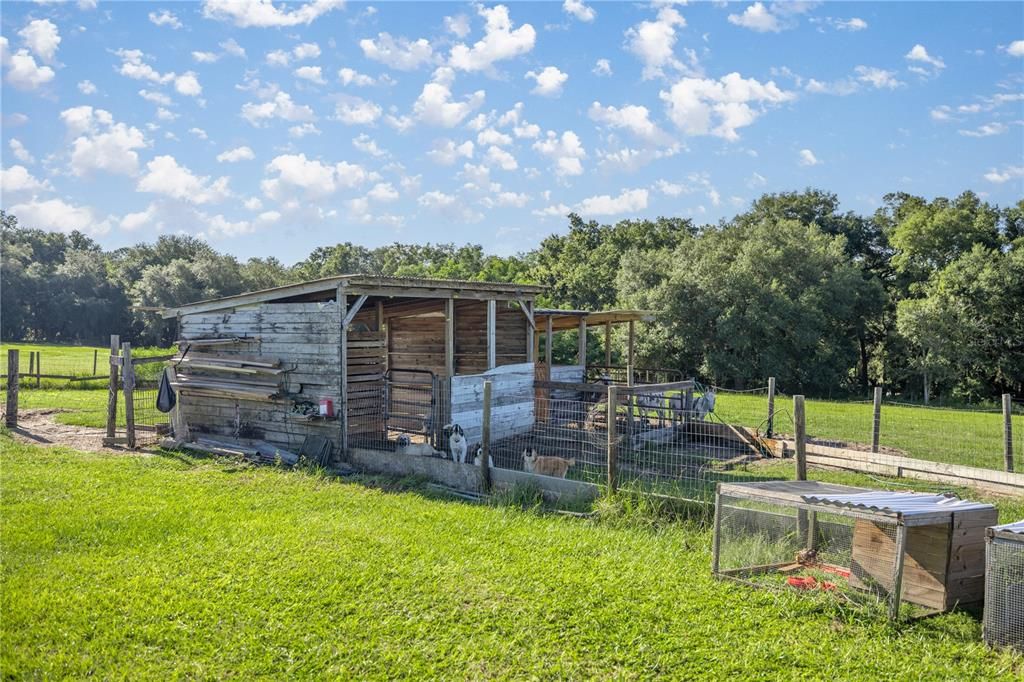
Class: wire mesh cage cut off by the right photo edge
984,520,1024,651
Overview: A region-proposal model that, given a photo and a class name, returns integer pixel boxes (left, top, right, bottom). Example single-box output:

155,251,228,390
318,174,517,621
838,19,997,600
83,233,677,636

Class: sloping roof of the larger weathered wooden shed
160,274,544,318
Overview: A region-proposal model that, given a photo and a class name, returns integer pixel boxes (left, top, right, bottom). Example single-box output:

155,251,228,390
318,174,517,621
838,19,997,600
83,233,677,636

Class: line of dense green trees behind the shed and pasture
0,189,1024,400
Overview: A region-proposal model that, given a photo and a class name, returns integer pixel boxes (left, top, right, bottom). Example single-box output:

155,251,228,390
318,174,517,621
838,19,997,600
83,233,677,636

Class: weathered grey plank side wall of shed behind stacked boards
179,301,341,450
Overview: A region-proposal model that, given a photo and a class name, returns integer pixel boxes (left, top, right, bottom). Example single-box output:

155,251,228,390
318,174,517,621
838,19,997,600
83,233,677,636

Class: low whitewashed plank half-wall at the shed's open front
452,364,535,443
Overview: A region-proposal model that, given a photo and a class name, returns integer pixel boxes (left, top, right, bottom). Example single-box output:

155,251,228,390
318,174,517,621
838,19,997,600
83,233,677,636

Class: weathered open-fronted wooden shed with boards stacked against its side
162,274,542,453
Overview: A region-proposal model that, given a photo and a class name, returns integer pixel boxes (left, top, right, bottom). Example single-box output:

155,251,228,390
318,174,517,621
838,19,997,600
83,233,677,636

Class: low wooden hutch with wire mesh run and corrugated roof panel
712,481,995,619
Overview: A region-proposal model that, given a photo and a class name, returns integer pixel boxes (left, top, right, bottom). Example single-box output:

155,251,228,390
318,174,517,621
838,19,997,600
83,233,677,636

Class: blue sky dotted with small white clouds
0,0,1024,263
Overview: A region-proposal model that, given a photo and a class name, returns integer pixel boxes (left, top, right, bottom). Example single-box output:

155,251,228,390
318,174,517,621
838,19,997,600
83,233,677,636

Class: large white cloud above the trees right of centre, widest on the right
659,72,795,141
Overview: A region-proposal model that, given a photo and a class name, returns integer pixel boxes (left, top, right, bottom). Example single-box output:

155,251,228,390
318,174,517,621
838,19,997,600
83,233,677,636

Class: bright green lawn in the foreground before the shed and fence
0,436,1024,680
